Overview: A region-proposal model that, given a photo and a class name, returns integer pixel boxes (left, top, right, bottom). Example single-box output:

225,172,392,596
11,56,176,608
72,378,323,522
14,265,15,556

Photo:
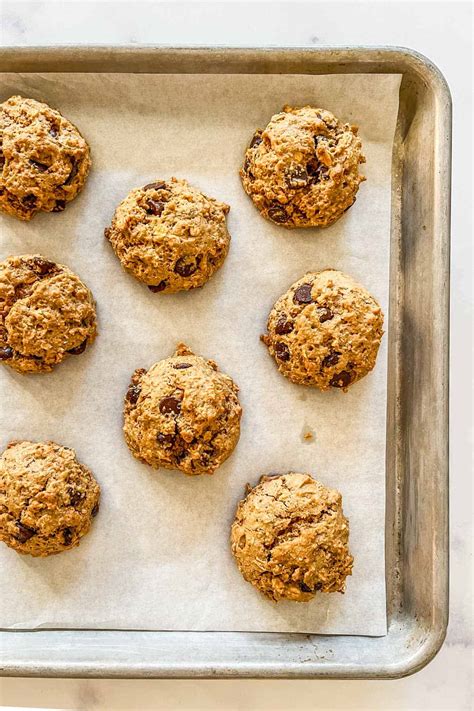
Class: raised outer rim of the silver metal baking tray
0,44,451,678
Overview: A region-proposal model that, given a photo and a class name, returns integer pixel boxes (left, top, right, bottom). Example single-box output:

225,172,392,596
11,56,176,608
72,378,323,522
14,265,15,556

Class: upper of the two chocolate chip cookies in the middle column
105,178,230,293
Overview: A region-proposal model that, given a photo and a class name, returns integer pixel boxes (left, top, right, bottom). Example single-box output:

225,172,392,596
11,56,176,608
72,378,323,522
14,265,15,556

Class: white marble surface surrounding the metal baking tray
0,0,473,711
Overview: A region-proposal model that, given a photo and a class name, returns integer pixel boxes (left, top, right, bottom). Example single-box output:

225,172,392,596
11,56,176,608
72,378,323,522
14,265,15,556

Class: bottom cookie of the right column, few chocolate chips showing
231,472,353,602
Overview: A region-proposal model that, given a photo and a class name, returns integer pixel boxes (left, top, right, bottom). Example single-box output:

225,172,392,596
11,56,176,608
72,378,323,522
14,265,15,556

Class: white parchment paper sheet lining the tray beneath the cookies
0,74,400,635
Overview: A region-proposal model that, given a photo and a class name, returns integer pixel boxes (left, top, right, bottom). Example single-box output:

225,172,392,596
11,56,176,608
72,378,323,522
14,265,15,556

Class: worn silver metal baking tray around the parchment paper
0,47,451,679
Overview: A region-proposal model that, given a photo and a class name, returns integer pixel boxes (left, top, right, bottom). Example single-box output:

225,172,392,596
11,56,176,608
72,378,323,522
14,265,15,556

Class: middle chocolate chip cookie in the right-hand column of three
261,269,383,391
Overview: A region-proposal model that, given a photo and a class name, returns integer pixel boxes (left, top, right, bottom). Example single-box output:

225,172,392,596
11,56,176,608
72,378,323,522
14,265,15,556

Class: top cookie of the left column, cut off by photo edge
0,96,91,220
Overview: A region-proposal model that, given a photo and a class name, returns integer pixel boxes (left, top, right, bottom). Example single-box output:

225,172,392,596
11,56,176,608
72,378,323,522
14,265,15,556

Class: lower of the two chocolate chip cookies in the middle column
123,343,242,475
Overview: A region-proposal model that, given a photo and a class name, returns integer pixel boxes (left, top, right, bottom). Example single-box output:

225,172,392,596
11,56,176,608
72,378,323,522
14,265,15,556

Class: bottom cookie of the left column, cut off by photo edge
0,441,100,557
